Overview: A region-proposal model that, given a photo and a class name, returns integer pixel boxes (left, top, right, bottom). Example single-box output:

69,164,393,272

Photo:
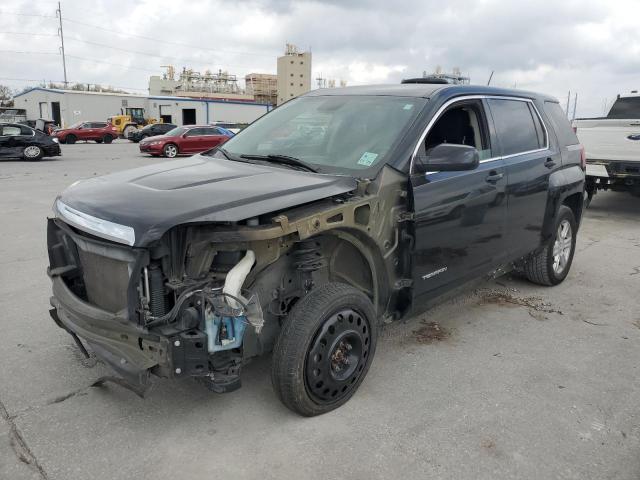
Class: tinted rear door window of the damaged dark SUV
489,99,546,155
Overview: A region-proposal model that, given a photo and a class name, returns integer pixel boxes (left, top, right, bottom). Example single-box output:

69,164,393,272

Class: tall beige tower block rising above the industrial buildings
277,43,311,105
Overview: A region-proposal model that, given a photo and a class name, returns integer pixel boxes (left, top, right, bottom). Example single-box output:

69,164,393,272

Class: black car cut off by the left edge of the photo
0,123,61,160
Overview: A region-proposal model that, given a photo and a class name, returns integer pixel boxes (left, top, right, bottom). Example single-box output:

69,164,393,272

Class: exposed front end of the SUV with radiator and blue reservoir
48,218,264,392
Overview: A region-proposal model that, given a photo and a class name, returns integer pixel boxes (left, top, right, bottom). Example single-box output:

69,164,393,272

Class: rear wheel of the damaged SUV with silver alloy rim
524,205,578,286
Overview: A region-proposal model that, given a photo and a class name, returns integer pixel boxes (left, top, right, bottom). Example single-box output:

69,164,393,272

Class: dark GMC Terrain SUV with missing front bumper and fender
48,84,585,416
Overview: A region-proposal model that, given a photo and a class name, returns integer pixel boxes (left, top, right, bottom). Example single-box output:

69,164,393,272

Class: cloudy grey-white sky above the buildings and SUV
0,0,640,116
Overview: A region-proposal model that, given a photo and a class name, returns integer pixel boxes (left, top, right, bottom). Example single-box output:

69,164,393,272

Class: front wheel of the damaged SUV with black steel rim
271,283,378,417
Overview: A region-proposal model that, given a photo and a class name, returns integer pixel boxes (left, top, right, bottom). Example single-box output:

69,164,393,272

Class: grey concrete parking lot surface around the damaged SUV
0,141,640,480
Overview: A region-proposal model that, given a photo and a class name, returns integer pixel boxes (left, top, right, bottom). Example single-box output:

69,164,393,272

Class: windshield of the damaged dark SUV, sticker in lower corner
219,95,426,171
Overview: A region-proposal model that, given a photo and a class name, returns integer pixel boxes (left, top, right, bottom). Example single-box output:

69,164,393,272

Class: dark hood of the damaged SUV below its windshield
59,155,356,246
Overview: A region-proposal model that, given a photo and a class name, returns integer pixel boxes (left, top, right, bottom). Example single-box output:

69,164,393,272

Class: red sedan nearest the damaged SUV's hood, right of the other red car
139,125,233,158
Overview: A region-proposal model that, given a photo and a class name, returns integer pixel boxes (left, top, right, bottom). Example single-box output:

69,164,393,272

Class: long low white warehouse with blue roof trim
14,87,271,126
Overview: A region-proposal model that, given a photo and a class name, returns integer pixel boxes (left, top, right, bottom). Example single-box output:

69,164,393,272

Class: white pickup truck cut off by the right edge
573,91,640,205
